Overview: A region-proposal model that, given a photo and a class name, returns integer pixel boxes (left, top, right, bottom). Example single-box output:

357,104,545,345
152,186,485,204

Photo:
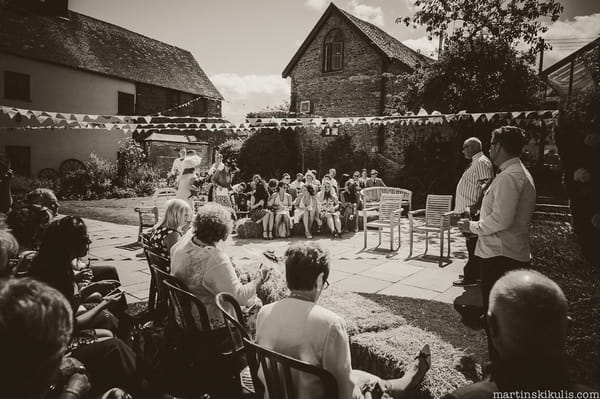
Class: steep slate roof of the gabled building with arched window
282,3,433,78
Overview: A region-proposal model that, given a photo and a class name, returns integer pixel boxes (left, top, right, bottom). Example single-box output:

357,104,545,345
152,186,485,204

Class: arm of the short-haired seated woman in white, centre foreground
323,320,354,398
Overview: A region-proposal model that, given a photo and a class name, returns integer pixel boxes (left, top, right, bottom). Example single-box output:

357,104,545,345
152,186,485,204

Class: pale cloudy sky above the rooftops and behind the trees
69,0,600,122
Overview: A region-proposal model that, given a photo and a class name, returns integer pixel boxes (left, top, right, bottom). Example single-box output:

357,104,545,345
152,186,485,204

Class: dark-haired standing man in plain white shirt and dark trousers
459,126,536,362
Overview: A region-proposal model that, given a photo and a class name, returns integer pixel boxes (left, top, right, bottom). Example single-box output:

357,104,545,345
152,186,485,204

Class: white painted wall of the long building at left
0,53,135,176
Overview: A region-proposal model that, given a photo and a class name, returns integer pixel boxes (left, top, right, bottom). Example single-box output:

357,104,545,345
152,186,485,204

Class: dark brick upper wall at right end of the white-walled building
135,83,221,117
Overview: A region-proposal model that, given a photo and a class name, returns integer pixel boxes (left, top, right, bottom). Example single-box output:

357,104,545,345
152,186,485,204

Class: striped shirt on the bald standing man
454,151,494,213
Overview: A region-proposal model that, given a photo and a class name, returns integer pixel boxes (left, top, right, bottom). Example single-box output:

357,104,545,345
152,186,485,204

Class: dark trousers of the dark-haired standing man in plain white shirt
479,256,529,362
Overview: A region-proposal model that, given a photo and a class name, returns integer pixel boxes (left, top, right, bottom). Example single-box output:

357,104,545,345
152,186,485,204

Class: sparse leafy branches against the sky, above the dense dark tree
396,0,563,54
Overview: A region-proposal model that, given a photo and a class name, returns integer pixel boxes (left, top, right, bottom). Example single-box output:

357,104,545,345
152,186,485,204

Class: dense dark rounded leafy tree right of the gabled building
395,37,539,113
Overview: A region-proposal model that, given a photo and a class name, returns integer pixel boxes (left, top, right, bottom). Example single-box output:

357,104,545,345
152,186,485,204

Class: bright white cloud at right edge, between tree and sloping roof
544,13,600,68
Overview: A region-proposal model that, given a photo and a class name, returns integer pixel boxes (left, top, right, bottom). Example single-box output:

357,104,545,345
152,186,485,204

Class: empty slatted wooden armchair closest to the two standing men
408,195,452,267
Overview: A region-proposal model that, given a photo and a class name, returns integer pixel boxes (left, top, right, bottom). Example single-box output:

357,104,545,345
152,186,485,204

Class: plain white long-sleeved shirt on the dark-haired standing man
469,157,536,262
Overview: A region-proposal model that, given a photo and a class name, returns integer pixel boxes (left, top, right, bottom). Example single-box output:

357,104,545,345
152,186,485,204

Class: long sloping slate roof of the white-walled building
0,7,223,99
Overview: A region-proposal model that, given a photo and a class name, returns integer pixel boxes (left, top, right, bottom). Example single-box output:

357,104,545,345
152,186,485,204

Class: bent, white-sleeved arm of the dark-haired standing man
469,174,520,235
